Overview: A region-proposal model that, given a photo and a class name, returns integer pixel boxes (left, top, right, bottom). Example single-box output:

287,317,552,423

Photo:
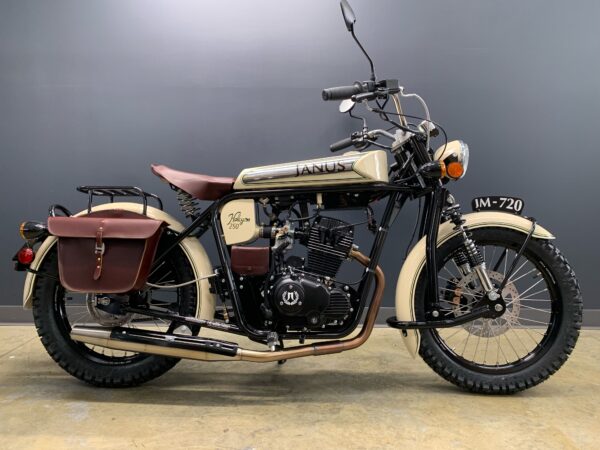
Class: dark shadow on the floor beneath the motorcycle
2,361,492,406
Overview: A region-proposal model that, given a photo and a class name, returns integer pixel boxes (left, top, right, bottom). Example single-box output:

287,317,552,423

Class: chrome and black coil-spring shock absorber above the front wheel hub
443,203,500,301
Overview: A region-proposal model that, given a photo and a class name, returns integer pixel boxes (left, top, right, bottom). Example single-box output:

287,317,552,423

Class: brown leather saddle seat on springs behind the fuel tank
151,164,235,200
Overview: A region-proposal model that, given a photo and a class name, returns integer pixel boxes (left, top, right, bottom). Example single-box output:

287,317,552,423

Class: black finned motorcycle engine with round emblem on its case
269,216,358,329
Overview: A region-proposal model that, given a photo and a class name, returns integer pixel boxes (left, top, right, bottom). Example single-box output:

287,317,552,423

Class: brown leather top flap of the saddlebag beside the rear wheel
48,216,165,239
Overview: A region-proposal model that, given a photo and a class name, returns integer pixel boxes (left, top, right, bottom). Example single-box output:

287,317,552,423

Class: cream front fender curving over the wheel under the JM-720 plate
396,211,554,358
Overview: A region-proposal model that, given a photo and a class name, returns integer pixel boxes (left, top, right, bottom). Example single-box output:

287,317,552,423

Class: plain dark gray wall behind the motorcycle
0,0,600,308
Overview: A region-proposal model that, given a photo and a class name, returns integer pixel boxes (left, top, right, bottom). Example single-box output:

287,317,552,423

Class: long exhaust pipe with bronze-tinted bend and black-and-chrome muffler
71,250,385,362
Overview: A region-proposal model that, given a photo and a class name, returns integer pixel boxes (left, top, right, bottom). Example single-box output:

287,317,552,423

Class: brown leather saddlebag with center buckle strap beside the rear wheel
48,211,165,293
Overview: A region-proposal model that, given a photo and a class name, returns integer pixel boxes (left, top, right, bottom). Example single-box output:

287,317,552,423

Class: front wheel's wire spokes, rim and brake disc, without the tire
435,242,561,370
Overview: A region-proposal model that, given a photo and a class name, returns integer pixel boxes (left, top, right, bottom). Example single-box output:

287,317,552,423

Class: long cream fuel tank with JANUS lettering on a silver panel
233,150,388,190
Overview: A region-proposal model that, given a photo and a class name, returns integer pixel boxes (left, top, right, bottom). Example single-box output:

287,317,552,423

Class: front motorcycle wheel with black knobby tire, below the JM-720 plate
415,228,582,394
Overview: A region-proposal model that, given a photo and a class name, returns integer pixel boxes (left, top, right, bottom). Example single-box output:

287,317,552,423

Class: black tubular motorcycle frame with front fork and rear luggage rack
18,132,460,342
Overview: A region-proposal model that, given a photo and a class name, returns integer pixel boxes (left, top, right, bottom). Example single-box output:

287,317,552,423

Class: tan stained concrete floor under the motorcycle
0,326,600,449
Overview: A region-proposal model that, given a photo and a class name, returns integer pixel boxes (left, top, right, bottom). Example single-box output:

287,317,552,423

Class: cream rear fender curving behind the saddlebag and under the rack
23,202,215,319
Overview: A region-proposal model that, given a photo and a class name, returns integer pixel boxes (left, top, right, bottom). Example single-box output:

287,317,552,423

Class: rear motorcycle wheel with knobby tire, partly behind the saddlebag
33,234,197,387
